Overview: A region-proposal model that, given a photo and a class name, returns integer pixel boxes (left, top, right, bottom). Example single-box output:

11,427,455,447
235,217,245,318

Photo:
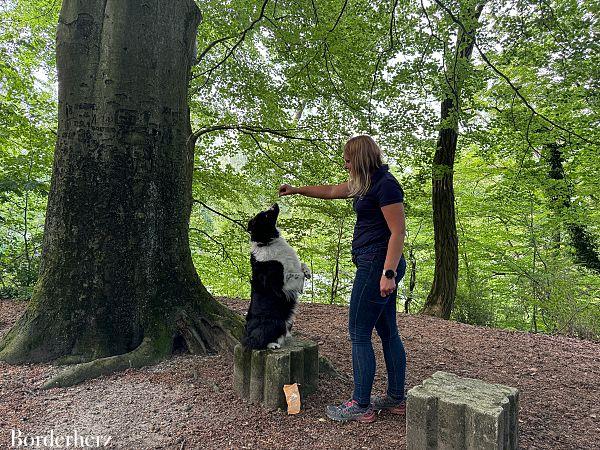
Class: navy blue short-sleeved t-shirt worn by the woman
352,164,404,251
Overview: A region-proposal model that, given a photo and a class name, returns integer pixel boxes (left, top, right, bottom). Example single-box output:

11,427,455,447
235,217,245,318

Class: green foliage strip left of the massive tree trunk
0,1,58,297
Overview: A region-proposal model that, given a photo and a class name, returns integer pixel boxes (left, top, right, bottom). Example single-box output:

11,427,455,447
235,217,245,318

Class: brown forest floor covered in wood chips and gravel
0,299,600,450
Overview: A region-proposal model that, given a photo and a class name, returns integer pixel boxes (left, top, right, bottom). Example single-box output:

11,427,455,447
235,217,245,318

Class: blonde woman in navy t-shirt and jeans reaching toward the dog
279,135,406,422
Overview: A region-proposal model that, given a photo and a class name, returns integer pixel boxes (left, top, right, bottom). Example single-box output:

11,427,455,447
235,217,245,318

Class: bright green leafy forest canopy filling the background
0,0,600,338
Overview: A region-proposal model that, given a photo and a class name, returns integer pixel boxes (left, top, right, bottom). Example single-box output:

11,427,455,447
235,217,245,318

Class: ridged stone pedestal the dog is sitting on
233,337,319,409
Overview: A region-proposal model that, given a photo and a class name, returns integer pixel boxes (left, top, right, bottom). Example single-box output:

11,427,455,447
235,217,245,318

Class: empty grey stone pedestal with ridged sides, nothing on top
406,372,519,450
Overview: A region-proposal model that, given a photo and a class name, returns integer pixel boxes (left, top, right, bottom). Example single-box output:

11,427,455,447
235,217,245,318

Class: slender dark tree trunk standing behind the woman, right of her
421,2,484,319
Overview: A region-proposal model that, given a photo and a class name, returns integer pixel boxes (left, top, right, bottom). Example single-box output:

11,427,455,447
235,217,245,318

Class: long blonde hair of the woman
344,134,383,197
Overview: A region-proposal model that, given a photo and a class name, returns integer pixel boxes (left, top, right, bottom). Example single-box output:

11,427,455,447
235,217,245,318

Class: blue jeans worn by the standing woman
348,249,406,406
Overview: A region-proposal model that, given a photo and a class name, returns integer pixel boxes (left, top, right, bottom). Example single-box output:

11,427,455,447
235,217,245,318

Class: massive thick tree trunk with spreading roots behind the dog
0,0,243,385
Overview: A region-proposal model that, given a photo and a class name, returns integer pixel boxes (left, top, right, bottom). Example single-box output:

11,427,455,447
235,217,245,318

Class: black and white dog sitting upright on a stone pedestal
242,203,311,349
